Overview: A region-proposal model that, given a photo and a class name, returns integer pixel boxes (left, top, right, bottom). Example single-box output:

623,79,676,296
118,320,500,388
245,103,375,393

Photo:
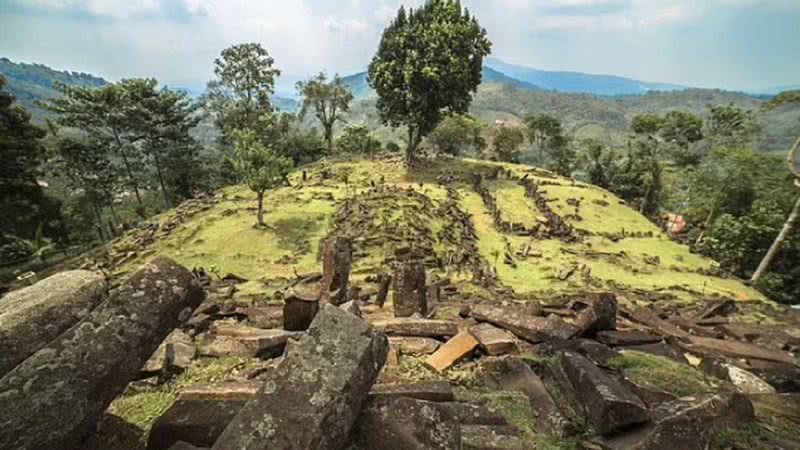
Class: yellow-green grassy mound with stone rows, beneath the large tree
90,158,763,301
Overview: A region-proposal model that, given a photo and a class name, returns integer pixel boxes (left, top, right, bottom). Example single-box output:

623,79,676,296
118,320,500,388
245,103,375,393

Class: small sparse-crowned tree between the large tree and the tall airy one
297,72,353,153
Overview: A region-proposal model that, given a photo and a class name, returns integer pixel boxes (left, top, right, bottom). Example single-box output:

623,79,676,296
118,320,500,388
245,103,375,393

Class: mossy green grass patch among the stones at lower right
609,350,713,397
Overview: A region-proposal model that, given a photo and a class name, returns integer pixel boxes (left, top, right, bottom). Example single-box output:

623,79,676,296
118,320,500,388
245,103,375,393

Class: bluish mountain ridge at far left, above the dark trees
0,58,108,121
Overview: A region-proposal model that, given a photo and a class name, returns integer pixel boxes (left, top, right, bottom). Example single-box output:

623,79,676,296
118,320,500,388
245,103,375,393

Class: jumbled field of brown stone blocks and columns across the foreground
0,244,800,450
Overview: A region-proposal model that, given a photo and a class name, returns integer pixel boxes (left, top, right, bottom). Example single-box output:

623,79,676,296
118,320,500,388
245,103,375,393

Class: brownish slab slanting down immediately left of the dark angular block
495,357,571,437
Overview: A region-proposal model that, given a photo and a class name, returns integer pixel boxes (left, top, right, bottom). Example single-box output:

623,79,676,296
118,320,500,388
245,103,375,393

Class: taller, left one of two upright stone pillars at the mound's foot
320,236,353,305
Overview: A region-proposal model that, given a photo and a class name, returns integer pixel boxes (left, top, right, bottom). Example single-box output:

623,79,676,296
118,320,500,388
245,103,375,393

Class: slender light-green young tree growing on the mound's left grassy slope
231,129,292,227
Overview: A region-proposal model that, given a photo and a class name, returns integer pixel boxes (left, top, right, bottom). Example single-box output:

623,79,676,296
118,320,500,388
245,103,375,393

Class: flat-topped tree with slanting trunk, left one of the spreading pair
42,79,157,205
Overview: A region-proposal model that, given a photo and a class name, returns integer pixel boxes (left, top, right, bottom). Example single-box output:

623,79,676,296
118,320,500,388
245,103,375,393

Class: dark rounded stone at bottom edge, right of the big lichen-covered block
351,397,461,450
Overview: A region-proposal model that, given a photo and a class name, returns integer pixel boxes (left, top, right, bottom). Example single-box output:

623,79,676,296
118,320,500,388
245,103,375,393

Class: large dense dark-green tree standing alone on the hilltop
368,0,491,162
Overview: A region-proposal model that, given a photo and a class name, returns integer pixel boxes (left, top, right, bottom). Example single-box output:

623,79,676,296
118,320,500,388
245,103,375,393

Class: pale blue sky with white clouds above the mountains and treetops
0,0,800,90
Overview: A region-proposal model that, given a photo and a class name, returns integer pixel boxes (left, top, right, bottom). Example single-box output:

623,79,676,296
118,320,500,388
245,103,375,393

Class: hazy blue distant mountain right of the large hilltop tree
485,58,687,96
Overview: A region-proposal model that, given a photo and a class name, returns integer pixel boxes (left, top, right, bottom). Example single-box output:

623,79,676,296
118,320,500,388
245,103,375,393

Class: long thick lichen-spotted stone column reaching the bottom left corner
0,258,204,449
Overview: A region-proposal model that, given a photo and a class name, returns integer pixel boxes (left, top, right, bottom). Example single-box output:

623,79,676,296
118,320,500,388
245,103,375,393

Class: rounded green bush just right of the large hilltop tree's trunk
428,114,486,156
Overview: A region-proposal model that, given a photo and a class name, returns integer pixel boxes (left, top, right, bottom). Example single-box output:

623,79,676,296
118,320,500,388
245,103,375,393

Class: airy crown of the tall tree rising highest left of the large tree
206,43,281,137
